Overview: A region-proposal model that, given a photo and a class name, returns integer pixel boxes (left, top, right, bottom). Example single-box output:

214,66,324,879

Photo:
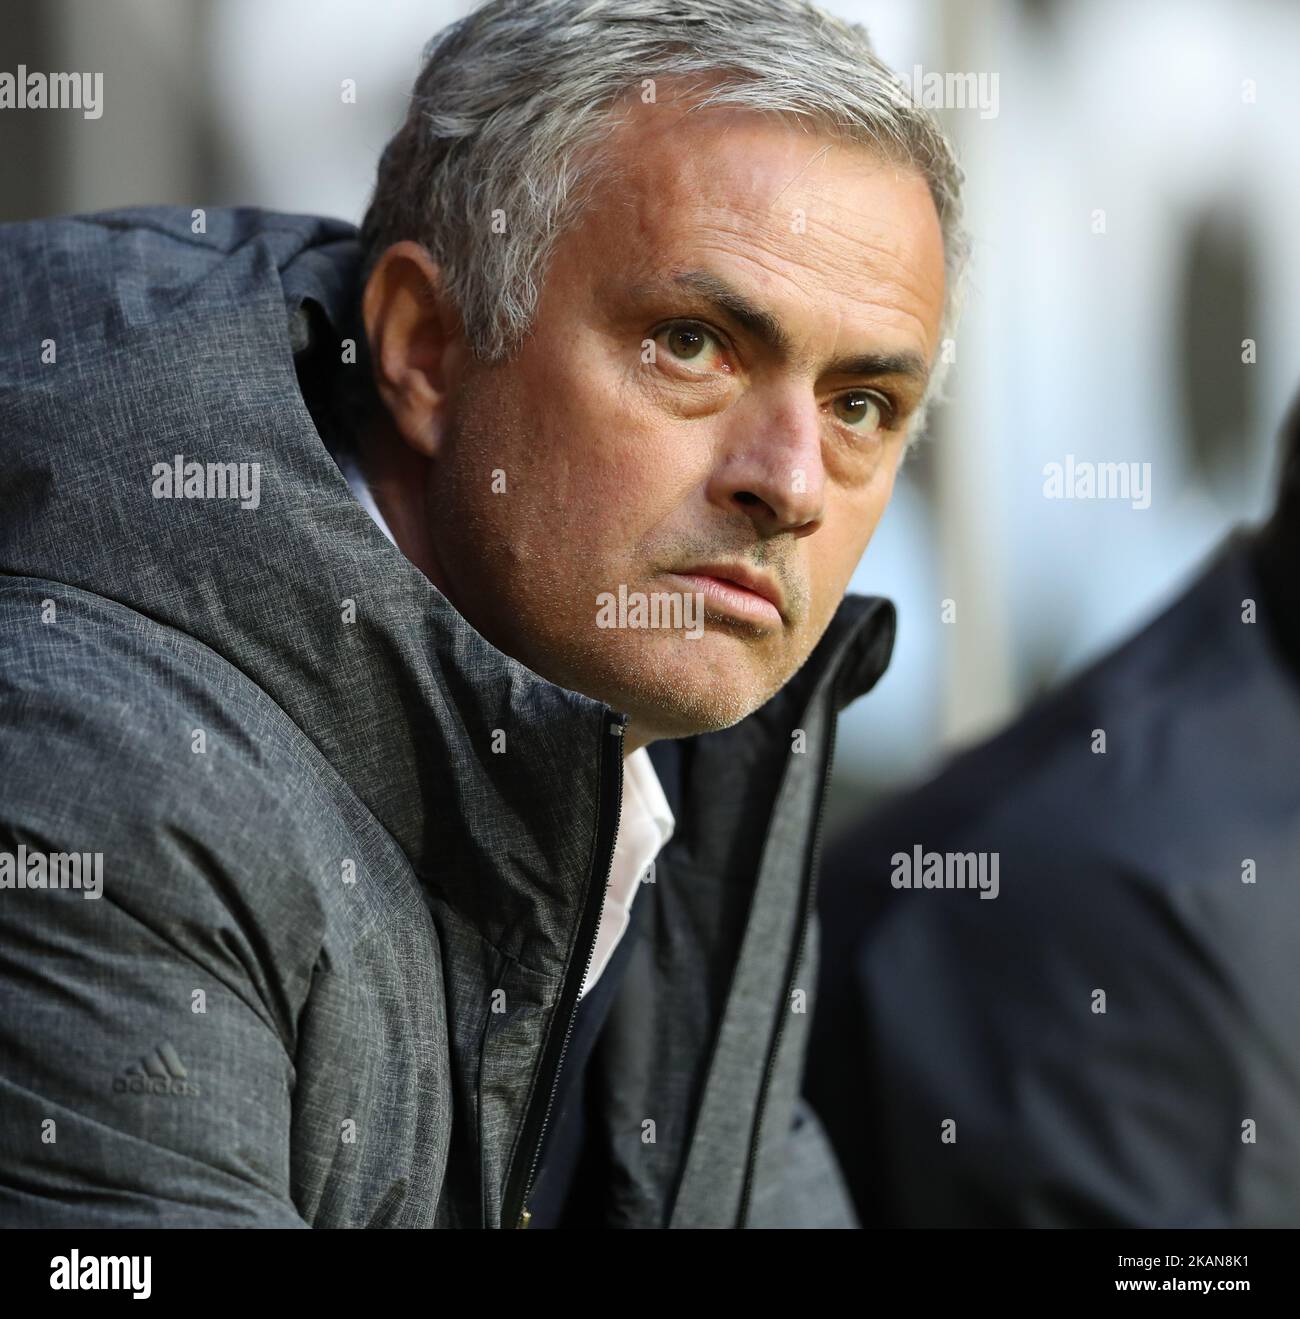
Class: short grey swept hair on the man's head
361,0,969,434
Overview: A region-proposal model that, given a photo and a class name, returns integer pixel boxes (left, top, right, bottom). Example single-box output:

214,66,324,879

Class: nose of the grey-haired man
708,400,825,538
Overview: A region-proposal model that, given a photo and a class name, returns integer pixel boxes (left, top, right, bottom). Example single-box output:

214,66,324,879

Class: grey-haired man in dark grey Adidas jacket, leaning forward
0,0,964,1227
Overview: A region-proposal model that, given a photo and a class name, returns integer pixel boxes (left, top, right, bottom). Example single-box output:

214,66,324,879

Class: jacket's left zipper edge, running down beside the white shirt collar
501,712,628,1228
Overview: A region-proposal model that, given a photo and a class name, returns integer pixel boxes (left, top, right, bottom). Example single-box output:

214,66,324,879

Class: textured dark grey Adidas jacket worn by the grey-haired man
0,207,894,1227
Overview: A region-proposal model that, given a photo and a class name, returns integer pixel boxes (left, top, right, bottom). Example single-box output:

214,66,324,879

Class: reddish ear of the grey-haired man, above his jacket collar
361,241,465,458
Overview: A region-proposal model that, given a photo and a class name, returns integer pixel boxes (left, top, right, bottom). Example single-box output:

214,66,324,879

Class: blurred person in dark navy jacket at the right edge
807,402,1300,1227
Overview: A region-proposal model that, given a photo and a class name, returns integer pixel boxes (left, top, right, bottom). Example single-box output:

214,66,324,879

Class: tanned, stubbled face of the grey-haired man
427,104,944,745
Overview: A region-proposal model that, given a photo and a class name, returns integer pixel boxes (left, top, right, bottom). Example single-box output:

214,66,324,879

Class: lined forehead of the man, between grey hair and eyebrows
581,95,944,359
